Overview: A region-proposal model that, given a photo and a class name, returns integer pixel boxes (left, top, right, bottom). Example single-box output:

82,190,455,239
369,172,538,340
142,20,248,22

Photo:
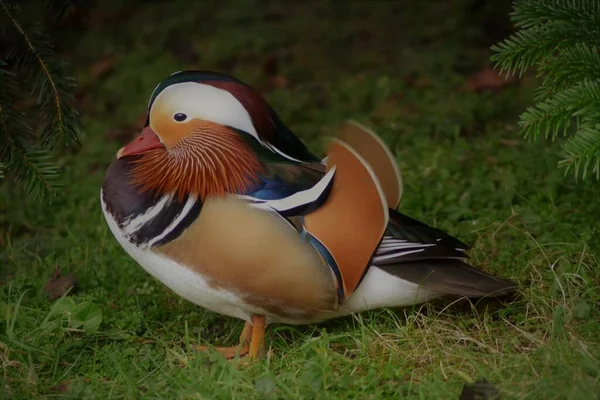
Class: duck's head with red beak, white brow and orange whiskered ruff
117,71,294,202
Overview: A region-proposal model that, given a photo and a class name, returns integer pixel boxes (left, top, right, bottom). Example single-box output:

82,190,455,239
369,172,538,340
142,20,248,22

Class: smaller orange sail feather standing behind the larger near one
338,121,402,209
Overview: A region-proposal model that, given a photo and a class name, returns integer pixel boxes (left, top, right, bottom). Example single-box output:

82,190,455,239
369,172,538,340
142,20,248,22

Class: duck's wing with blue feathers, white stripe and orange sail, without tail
240,140,389,297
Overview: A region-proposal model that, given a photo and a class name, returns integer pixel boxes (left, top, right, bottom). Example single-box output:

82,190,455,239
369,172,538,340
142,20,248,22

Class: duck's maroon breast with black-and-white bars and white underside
100,157,250,320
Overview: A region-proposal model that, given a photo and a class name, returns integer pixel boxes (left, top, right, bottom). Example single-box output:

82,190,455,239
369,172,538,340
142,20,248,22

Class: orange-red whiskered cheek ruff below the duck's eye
131,121,262,201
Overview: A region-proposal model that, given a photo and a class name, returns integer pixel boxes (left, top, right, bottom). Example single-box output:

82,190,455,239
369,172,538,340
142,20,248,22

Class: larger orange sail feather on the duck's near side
305,140,389,296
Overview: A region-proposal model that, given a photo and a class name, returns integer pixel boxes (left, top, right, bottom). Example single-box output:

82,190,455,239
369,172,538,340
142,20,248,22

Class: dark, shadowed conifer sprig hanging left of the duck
0,0,81,198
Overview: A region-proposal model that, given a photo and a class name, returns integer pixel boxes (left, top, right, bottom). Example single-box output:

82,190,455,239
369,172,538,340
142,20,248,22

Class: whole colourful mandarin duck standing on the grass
100,71,515,358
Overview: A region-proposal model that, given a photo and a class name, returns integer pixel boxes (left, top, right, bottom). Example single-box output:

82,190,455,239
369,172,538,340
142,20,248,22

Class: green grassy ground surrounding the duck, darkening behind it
0,0,600,399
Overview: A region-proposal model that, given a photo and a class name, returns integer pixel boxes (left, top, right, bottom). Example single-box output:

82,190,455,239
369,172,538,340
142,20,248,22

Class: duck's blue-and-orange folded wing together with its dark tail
239,133,516,300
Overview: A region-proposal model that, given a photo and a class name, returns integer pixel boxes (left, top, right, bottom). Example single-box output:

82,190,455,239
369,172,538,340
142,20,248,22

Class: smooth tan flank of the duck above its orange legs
156,196,338,314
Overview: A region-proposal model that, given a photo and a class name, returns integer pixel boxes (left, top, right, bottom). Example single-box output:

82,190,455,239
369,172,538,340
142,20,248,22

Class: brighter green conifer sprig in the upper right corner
492,0,600,179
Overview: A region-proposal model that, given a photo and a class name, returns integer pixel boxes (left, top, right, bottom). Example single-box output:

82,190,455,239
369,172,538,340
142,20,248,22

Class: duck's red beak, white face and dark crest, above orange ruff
118,71,319,161
